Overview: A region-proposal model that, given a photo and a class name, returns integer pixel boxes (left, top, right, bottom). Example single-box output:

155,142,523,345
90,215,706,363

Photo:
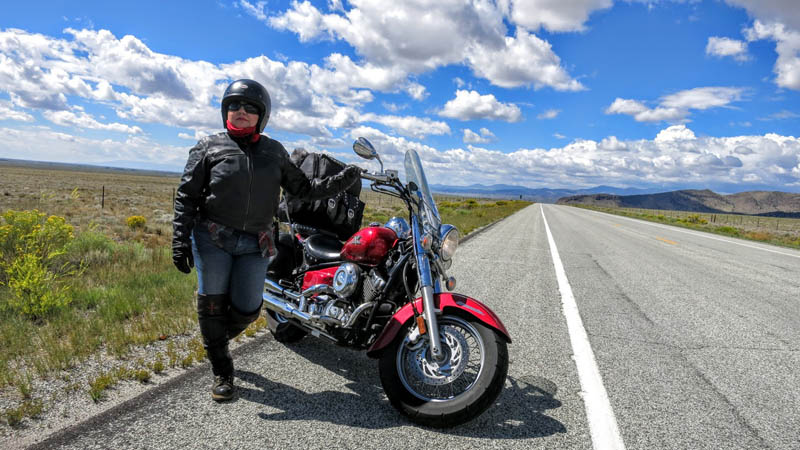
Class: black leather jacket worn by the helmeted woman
172,132,360,248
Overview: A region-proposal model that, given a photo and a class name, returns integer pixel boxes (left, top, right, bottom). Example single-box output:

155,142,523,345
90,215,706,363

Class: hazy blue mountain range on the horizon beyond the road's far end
430,184,656,203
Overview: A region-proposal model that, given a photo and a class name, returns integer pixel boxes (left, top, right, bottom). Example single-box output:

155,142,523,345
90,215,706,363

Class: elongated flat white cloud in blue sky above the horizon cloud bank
605,87,745,122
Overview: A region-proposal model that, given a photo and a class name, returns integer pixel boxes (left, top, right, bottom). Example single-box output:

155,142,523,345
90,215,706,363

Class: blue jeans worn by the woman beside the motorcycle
192,222,271,314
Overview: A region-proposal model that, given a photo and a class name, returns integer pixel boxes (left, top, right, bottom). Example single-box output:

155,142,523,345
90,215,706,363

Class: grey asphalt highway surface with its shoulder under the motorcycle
32,205,800,449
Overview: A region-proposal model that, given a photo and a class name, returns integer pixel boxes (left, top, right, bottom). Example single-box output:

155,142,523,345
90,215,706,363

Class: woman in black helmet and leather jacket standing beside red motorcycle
172,80,360,401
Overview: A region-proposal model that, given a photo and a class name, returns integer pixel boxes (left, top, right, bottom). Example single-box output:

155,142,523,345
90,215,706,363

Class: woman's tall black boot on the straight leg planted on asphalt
197,294,235,401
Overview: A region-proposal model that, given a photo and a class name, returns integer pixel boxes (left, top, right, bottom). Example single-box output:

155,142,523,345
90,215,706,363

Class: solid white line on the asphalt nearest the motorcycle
539,205,625,450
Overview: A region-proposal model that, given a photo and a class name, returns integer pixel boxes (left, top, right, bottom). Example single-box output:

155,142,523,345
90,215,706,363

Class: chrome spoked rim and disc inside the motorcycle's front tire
396,316,485,402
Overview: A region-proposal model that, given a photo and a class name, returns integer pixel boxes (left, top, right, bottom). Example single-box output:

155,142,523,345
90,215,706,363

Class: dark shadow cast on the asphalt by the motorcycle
237,339,567,439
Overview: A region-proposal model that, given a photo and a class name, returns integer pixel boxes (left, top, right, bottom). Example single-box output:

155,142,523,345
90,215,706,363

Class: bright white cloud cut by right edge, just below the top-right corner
745,20,800,90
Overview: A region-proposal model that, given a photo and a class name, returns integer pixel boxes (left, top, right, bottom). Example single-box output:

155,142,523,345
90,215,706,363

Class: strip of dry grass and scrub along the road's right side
573,205,800,249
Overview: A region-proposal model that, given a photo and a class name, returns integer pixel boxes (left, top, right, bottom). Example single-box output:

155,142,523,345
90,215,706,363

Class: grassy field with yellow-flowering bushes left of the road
0,166,529,427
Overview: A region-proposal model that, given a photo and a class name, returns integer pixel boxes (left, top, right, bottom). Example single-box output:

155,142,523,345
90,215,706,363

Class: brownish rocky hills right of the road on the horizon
557,189,800,217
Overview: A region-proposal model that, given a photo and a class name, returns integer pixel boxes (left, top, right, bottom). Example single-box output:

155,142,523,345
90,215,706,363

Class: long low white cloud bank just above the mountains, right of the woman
351,126,800,188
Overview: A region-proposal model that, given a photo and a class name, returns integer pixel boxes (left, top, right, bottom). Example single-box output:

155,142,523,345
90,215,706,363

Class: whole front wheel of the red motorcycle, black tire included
378,314,508,428
